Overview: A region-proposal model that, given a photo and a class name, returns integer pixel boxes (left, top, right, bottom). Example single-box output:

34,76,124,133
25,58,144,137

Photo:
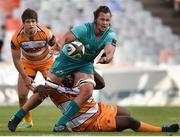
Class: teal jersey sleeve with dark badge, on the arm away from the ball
105,32,117,47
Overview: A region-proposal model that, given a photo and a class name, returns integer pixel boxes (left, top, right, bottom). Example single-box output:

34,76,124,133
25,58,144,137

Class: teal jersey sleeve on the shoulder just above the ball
71,24,87,40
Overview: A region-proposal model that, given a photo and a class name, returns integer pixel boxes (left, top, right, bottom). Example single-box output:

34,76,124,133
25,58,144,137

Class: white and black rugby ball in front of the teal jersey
67,41,85,59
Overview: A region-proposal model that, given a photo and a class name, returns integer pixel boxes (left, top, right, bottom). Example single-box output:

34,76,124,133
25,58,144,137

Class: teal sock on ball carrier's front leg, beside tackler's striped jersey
56,101,81,126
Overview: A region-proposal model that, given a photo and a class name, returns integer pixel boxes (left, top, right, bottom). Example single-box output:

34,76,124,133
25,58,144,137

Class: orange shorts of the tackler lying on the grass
82,103,117,132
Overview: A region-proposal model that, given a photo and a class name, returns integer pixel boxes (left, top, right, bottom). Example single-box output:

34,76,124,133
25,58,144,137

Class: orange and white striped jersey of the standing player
11,24,55,62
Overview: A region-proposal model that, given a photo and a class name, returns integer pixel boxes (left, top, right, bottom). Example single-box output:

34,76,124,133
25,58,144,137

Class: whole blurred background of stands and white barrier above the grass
0,0,180,106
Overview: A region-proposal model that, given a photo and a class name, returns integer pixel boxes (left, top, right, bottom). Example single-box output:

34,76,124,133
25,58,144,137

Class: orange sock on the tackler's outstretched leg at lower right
136,122,162,132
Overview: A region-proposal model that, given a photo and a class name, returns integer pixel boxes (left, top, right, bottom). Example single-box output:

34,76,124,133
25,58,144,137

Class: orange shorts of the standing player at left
22,57,54,77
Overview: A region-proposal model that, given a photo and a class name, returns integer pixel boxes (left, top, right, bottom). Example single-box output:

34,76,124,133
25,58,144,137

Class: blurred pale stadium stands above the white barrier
0,0,180,66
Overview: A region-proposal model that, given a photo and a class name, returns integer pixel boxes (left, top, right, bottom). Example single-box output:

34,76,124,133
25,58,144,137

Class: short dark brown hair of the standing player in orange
21,8,38,23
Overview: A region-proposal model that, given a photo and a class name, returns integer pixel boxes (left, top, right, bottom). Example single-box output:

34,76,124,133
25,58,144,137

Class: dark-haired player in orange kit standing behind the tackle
11,8,56,128
